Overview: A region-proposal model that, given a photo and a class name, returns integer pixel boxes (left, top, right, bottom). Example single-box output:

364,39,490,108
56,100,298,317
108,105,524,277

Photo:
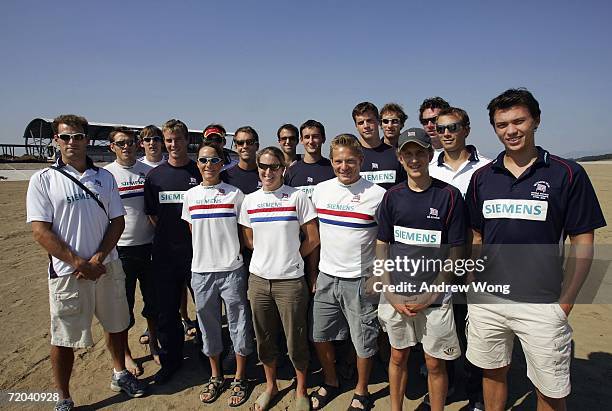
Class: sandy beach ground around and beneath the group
0,163,612,410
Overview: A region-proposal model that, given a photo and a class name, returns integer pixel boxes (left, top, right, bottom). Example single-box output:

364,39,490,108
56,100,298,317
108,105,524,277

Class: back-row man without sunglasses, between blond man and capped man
352,101,406,190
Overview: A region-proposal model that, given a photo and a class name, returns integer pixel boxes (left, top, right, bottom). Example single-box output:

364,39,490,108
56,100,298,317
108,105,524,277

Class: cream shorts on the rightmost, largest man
466,303,572,398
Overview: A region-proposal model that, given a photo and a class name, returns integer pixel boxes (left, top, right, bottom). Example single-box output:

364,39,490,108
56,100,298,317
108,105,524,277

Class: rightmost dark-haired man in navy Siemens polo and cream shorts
466,89,606,411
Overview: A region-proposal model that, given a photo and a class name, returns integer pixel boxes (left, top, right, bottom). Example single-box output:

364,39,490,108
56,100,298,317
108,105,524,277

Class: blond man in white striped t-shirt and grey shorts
311,134,385,410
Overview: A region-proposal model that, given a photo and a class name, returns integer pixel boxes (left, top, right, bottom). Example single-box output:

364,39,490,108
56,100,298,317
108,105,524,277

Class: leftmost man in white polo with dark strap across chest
26,115,145,411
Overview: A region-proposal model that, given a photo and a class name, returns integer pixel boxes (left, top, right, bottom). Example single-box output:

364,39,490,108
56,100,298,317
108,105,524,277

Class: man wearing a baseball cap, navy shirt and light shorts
374,128,466,410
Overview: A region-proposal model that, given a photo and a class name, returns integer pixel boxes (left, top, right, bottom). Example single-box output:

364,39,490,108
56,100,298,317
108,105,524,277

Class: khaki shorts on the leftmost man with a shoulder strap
49,259,130,348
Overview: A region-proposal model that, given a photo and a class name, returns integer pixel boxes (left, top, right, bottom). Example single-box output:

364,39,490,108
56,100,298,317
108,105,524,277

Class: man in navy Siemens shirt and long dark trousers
144,119,202,384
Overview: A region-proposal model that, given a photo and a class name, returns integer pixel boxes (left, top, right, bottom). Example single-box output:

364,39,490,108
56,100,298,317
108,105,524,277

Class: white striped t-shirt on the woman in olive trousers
239,185,317,280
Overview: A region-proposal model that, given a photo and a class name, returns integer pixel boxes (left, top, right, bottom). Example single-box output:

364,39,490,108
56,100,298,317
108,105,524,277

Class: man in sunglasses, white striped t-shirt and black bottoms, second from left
104,128,159,375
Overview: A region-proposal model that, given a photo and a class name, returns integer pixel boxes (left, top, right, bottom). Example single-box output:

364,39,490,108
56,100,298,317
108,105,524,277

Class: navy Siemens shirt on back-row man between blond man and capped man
361,142,406,190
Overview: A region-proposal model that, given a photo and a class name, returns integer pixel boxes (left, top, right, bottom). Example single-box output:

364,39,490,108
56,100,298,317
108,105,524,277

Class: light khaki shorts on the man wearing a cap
378,295,461,360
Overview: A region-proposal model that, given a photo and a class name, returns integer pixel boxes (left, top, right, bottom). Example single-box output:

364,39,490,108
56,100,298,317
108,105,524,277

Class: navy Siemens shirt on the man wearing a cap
376,178,467,294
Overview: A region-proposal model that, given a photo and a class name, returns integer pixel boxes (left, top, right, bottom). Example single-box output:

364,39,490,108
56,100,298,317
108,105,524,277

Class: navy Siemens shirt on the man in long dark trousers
144,160,202,258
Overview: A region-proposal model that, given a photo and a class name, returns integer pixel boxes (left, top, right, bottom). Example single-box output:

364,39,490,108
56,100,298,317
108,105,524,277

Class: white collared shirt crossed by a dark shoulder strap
26,157,125,278
